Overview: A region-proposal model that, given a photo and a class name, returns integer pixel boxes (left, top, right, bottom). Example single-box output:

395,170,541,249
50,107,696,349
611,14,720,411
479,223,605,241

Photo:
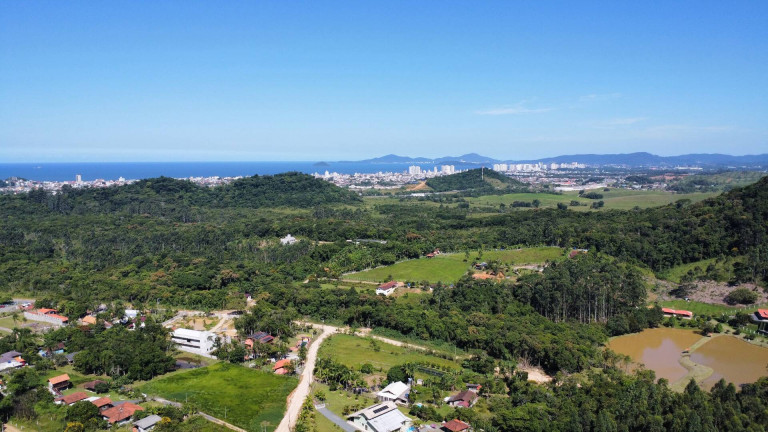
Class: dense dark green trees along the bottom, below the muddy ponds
474,367,768,432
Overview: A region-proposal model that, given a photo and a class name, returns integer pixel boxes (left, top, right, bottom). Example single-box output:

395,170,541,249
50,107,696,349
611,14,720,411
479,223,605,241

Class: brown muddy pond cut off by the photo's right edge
691,336,768,388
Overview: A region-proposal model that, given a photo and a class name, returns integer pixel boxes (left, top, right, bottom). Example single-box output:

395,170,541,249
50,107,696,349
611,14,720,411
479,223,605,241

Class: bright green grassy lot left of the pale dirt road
141,363,298,431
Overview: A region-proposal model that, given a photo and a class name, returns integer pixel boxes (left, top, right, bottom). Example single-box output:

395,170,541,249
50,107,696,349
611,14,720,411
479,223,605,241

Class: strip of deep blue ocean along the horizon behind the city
0,162,480,181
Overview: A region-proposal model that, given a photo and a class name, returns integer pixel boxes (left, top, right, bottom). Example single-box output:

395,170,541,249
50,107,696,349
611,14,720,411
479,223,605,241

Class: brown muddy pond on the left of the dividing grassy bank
608,327,701,383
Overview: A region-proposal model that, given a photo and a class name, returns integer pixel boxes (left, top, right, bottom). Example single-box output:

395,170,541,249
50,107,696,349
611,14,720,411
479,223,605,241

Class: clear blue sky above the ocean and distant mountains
0,0,768,162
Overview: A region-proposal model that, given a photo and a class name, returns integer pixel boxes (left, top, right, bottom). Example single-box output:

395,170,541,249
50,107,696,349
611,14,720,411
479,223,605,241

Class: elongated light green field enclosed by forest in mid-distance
344,247,563,283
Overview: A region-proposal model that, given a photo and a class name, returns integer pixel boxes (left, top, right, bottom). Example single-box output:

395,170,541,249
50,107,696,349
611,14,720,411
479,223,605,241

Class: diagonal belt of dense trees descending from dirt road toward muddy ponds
264,278,648,372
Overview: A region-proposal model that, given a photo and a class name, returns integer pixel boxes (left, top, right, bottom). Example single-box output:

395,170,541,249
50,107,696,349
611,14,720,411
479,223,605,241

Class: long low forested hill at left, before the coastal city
16,172,360,215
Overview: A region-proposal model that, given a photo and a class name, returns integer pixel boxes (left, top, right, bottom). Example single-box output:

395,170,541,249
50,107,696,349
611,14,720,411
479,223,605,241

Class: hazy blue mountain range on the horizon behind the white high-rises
344,152,768,167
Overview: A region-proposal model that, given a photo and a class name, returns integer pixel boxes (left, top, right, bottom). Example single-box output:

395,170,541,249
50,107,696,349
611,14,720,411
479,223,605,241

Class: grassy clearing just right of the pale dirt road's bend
320,334,460,378
